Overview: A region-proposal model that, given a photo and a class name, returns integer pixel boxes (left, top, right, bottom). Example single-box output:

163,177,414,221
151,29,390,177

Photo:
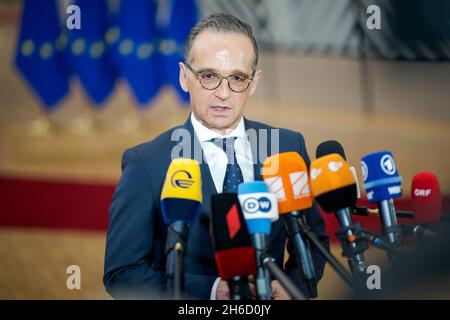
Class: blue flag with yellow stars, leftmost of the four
15,0,69,111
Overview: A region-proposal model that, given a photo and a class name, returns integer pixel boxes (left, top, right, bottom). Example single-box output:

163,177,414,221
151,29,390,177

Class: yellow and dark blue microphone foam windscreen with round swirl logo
161,158,202,224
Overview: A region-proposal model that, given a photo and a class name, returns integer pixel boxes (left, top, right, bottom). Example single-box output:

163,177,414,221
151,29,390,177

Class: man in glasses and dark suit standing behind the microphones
103,14,329,299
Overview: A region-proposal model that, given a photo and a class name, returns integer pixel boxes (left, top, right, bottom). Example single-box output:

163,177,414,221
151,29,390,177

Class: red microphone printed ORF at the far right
401,172,442,237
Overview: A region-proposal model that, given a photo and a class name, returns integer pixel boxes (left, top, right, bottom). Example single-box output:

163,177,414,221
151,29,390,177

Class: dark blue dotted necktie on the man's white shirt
213,137,244,193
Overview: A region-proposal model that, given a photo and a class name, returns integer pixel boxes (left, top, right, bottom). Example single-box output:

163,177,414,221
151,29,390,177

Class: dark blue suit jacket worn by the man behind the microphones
103,115,329,299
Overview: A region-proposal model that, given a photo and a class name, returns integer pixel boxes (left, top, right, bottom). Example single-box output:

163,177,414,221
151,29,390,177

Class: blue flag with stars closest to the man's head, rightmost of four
157,0,198,103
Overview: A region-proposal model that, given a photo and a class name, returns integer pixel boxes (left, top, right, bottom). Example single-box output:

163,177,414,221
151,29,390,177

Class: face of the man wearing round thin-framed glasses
180,30,261,134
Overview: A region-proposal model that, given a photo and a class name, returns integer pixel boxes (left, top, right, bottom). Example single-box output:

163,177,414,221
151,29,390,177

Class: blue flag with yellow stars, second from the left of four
67,0,116,107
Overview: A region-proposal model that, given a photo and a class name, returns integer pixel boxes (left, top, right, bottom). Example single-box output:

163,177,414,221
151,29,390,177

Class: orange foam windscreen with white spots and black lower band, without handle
310,153,357,212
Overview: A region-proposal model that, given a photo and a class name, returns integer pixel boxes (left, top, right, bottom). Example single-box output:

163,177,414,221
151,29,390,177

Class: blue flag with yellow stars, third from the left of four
114,0,161,108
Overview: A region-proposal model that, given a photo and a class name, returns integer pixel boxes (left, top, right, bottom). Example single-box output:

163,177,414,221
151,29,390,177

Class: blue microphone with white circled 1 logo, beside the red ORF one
361,151,402,249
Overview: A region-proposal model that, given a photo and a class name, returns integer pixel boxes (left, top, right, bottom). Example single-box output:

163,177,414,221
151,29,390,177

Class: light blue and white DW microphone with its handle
238,181,305,300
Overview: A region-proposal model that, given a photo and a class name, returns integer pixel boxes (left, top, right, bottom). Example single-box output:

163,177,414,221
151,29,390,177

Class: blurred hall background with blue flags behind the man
0,0,450,299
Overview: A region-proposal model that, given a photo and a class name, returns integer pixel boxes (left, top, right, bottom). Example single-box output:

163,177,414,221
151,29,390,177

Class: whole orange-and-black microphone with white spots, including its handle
310,153,368,283
